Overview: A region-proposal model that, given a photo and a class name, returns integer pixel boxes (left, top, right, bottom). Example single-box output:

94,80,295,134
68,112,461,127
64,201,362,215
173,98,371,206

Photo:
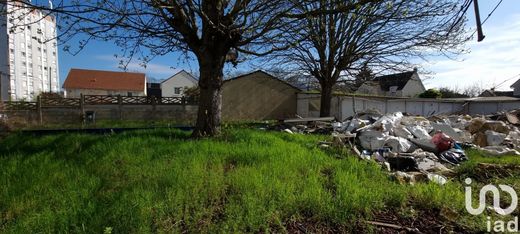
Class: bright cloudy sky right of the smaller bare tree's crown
422,0,520,90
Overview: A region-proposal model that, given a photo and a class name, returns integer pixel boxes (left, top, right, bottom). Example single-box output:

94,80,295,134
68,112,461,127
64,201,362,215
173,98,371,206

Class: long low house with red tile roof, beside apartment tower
63,68,146,98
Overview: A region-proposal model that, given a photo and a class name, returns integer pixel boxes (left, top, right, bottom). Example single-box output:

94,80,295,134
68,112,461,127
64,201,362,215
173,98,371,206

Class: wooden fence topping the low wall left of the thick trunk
0,95,197,110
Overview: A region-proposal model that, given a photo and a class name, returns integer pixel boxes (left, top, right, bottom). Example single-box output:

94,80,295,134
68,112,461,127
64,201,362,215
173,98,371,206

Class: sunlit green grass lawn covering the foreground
0,128,520,233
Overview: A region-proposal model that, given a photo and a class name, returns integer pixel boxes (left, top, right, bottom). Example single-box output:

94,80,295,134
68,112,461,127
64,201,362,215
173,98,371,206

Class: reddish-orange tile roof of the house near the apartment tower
63,68,146,91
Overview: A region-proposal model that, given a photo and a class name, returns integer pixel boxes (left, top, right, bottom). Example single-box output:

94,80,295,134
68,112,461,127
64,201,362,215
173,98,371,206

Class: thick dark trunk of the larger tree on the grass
192,56,224,138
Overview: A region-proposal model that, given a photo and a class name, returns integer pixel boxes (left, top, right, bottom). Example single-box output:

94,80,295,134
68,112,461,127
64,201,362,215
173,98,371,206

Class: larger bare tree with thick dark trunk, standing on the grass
7,0,382,137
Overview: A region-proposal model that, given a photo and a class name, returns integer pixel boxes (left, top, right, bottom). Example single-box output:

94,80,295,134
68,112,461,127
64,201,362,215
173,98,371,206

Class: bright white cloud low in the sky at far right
423,14,520,90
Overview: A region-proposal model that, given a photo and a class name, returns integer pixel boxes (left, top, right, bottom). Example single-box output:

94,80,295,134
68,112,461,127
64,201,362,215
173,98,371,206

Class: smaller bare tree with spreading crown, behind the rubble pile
274,0,471,116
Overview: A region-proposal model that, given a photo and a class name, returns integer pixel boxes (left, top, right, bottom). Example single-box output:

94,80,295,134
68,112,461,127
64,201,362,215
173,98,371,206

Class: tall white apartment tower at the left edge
0,0,59,101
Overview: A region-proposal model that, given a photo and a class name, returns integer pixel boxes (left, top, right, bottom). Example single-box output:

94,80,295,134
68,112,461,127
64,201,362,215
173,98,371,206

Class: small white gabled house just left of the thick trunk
161,70,197,97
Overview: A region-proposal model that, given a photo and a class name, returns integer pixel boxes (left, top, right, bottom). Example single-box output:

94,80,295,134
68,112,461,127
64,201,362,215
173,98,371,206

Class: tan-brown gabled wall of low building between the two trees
222,72,299,121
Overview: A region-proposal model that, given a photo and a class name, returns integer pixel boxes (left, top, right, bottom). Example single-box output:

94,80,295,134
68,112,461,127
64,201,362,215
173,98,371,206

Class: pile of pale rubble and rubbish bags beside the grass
284,111,520,184
